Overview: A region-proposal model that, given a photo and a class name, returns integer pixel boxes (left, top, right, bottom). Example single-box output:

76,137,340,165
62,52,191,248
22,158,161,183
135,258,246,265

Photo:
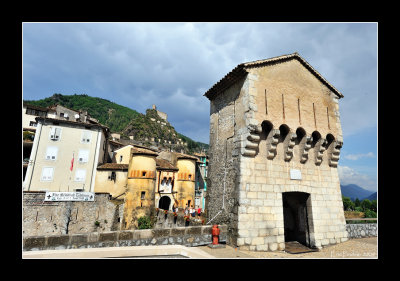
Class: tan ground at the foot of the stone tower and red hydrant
196,237,378,259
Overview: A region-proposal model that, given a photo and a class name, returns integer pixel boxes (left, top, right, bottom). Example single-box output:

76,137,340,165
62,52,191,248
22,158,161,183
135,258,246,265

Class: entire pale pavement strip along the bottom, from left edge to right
23,237,378,259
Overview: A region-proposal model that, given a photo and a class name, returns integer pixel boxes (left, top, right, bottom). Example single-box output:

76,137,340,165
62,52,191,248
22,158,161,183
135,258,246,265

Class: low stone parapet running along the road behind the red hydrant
23,225,227,251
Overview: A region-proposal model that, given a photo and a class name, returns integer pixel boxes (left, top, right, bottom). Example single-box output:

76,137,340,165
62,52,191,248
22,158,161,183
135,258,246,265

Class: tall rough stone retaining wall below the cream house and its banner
22,191,123,237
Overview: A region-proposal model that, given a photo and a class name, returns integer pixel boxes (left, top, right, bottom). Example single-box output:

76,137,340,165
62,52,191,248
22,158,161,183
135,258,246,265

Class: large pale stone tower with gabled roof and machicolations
205,53,347,251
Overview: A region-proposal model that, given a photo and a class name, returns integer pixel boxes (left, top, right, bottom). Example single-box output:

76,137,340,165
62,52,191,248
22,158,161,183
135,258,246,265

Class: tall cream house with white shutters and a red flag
23,115,109,192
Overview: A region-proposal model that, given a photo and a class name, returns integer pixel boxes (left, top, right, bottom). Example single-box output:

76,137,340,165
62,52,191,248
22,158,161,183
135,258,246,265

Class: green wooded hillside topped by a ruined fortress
24,93,208,153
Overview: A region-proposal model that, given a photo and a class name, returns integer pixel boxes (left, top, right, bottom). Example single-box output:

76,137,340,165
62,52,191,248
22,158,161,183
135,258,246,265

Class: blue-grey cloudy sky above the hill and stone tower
22,22,378,190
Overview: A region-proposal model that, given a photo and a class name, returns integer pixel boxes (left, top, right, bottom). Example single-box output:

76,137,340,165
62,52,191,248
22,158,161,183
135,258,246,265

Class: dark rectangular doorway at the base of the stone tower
282,192,310,247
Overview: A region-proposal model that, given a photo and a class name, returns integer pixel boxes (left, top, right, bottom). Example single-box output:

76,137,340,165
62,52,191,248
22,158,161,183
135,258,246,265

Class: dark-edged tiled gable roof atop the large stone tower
204,52,343,99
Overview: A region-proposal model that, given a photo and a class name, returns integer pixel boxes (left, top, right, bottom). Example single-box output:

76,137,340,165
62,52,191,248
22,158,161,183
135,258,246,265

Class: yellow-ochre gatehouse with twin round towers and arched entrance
95,145,197,229
